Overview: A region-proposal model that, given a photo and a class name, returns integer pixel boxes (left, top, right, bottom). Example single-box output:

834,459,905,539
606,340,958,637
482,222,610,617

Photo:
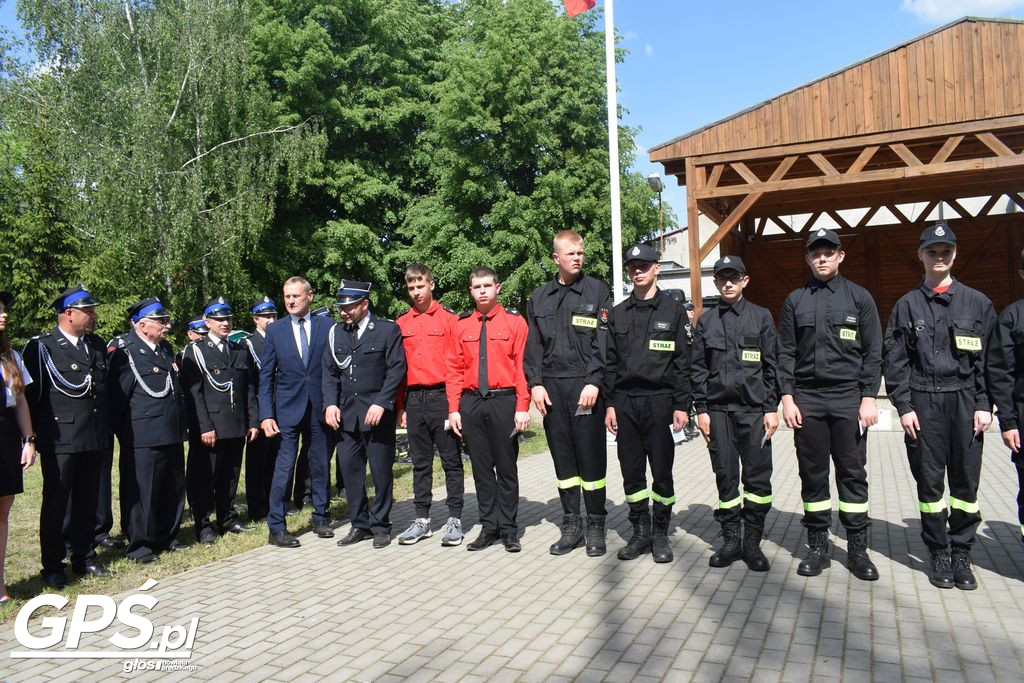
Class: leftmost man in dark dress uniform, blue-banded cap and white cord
23,285,113,588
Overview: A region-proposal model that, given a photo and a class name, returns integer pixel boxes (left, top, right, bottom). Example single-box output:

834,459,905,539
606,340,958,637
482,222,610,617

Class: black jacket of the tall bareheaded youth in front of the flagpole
523,273,611,390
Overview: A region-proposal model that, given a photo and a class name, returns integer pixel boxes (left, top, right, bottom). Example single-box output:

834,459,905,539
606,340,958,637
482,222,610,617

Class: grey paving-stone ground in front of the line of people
0,431,1024,683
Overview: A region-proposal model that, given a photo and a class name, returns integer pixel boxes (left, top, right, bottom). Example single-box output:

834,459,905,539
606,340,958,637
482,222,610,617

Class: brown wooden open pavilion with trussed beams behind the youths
649,17,1024,325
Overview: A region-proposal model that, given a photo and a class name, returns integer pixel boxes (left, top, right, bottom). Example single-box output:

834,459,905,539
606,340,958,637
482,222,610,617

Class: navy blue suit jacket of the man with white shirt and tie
259,315,334,426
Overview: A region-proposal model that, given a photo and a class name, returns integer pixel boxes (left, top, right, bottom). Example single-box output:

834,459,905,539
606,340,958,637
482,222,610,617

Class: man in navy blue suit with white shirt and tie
259,278,334,548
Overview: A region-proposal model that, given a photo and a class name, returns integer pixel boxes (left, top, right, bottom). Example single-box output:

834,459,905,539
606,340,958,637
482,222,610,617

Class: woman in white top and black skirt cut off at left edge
0,292,36,606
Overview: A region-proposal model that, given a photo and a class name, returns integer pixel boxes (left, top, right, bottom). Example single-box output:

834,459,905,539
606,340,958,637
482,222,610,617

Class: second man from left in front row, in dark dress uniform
110,299,188,564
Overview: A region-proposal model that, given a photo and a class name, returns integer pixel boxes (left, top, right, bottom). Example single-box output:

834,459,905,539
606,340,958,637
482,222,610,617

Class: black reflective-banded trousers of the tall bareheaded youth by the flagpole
544,378,608,515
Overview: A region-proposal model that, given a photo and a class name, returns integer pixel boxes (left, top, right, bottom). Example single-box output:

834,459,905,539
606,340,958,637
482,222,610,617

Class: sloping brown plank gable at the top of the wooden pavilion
648,16,1024,184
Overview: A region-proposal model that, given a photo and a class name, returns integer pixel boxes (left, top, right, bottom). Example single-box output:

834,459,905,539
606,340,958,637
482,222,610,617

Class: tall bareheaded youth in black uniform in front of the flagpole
523,230,611,557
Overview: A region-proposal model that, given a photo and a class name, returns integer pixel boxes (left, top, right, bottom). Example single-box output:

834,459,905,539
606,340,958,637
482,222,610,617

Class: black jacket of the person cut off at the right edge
985,299,1024,431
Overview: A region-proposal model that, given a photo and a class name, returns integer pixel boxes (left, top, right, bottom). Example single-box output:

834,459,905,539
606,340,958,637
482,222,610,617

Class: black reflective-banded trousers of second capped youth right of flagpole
708,410,772,529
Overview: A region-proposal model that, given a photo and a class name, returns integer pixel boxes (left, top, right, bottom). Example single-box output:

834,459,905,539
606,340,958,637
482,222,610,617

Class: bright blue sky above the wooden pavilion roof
0,0,1024,224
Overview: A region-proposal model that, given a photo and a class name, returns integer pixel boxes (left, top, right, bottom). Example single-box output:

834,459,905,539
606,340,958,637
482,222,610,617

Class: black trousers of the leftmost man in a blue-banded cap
39,451,103,571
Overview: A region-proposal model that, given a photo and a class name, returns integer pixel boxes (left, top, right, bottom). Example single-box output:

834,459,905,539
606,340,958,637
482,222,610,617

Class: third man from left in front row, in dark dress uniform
181,297,259,544
